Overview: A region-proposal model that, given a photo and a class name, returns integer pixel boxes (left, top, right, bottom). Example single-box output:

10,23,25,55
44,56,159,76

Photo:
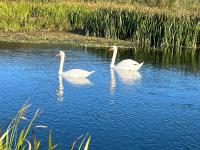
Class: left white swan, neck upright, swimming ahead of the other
56,51,95,78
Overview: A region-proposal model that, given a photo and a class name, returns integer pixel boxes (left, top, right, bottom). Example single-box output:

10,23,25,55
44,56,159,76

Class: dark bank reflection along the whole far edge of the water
0,42,200,73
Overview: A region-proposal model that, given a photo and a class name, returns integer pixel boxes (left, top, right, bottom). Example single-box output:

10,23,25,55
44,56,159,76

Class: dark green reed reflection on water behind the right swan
89,47,200,73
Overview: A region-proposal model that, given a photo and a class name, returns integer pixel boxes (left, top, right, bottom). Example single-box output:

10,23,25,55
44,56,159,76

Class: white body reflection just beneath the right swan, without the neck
116,70,142,84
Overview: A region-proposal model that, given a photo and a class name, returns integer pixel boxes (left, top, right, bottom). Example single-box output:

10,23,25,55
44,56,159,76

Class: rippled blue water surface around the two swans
0,43,200,150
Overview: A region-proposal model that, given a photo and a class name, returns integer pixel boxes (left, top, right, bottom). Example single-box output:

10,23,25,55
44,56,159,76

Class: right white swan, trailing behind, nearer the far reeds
109,46,144,71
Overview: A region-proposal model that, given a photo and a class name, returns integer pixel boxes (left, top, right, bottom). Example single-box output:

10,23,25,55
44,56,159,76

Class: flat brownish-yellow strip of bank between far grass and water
0,32,137,47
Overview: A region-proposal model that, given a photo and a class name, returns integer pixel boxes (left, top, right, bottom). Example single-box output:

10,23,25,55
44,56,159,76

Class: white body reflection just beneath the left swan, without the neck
64,77,92,85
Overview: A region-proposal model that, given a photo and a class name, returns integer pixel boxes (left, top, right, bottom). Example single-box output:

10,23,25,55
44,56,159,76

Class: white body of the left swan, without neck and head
62,69,94,78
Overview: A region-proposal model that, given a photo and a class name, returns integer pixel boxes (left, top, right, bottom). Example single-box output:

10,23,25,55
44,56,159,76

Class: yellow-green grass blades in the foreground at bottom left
0,103,91,150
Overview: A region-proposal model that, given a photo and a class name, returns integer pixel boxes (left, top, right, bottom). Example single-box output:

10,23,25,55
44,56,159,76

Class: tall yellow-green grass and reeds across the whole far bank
0,1,200,48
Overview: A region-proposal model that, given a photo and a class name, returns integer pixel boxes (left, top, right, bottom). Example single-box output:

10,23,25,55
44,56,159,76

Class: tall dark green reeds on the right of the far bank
85,8,200,47
